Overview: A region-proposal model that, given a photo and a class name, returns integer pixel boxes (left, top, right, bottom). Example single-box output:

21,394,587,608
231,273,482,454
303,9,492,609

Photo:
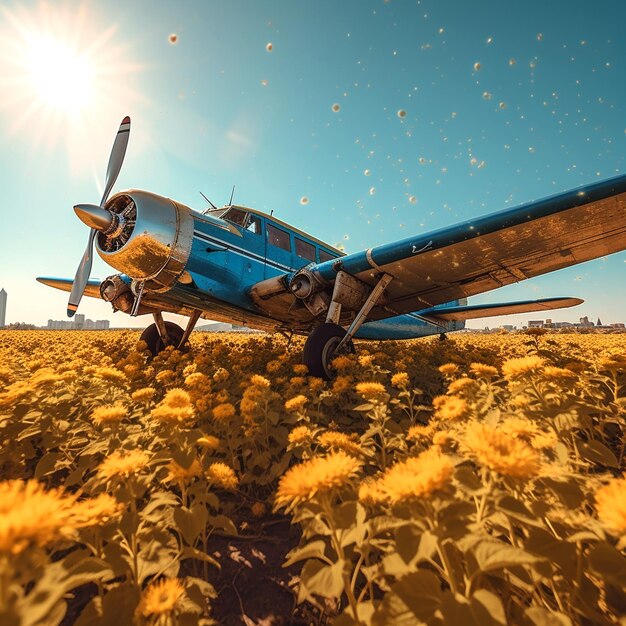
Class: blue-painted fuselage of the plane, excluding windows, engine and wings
177,207,464,339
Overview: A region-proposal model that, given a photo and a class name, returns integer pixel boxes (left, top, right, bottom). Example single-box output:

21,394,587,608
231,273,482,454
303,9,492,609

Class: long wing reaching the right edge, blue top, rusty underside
304,176,626,320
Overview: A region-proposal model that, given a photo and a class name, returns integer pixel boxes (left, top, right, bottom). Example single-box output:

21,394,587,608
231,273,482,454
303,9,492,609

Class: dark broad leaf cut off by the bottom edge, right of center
372,570,442,626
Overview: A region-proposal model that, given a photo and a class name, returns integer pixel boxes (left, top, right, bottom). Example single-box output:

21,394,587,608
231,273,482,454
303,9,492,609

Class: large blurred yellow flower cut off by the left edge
0,480,78,554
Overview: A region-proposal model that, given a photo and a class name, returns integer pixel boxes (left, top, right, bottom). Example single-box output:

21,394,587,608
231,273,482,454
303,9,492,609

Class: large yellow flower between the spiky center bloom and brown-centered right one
378,448,454,504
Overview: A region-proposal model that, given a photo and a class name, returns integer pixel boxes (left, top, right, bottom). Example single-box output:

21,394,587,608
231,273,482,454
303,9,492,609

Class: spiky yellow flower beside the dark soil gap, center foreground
276,451,361,511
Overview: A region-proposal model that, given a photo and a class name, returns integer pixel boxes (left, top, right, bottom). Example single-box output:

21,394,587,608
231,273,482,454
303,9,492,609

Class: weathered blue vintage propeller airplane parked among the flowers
37,116,626,379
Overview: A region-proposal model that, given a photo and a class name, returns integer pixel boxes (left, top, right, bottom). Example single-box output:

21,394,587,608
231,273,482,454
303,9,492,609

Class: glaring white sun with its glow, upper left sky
0,0,143,161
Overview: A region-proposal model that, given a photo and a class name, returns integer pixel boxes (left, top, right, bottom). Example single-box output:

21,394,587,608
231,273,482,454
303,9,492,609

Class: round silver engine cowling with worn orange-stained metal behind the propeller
96,189,194,292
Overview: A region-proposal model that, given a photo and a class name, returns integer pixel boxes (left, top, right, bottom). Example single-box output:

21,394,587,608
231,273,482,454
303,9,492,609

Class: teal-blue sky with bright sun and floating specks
0,0,626,327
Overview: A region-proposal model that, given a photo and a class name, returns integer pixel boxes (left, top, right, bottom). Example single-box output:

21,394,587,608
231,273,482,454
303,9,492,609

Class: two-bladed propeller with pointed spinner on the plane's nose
67,115,130,317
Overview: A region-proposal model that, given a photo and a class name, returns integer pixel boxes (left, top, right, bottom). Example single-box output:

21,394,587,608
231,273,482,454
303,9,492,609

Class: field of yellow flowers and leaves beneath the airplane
0,331,626,626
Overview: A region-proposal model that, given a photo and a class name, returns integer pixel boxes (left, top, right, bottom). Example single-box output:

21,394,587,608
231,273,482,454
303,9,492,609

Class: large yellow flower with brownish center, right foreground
465,422,541,478
